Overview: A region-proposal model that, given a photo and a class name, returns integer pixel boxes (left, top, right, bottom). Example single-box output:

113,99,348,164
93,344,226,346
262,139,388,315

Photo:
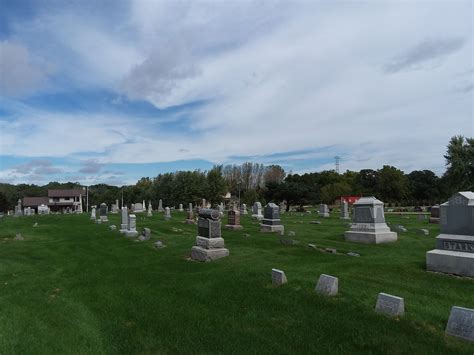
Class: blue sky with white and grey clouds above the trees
0,0,474,185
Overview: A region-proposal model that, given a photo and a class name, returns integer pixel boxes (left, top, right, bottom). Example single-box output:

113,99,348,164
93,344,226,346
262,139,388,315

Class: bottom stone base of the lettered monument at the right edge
426,249,474,277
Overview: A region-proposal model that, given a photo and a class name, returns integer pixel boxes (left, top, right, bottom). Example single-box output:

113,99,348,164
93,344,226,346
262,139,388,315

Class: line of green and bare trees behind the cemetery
0,136,474,212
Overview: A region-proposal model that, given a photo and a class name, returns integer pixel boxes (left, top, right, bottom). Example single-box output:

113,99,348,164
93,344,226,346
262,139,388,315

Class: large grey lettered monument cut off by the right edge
426,191,474,277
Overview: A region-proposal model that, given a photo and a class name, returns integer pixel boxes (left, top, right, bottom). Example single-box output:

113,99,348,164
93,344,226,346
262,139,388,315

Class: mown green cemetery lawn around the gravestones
0,212,474,354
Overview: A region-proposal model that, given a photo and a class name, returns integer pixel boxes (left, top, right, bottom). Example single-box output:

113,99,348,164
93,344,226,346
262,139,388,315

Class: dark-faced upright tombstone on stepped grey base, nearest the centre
191,208,229,261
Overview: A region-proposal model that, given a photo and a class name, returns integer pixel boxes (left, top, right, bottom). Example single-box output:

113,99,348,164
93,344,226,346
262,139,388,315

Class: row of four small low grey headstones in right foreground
272,269,474,341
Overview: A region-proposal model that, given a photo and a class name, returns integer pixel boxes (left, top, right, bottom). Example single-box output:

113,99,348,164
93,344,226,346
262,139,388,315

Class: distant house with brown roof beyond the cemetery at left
23,189,84,212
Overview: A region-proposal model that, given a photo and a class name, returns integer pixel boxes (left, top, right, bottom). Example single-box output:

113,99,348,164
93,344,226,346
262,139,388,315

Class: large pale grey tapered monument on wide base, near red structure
344,197,398,244
